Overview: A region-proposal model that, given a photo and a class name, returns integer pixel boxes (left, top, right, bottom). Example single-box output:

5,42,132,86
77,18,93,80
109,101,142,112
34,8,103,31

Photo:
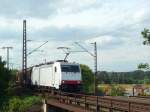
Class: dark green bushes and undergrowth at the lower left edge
0,58,41,112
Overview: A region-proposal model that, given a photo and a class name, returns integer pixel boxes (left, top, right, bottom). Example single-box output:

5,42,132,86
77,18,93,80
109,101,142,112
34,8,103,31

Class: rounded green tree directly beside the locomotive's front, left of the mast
80,64,94,92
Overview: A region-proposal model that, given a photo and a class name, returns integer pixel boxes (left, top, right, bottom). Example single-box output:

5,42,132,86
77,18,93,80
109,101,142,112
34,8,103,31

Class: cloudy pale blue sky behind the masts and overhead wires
0,0,150,72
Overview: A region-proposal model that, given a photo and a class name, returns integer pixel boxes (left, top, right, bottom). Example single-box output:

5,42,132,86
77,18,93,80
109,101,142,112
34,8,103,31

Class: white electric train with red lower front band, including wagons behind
19,61,82,92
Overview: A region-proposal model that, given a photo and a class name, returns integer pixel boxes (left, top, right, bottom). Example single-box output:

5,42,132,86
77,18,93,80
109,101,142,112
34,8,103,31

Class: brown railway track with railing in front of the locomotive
33,90,150,112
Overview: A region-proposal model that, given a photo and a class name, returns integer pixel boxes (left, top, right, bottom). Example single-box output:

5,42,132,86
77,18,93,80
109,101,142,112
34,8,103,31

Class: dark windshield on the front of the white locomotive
61,65,80,72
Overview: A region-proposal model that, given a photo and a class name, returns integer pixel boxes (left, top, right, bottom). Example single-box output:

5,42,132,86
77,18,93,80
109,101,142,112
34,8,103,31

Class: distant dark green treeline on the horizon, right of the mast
97,70,150,84
